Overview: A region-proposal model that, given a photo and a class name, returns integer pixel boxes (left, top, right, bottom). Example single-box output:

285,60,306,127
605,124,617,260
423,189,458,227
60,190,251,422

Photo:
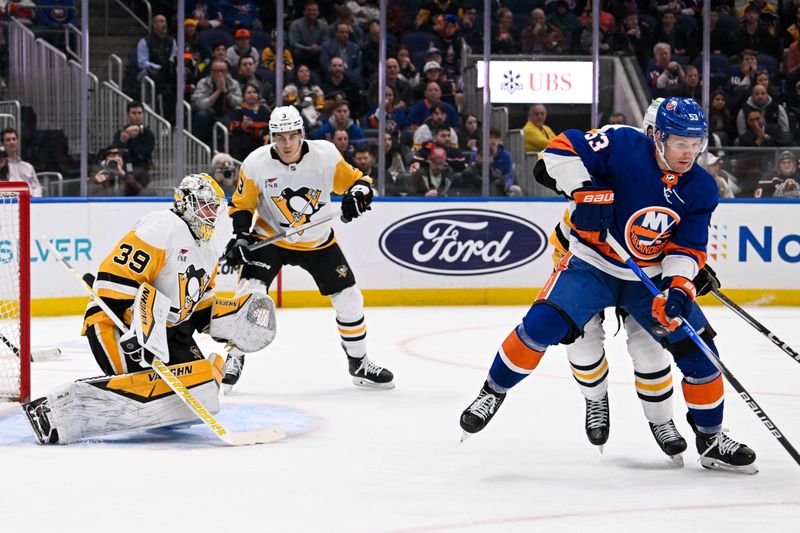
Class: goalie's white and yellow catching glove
208,292,277,353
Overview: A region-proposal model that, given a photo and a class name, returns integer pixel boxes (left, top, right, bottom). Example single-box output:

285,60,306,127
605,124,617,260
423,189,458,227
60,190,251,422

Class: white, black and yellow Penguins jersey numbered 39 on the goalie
83,210,220,335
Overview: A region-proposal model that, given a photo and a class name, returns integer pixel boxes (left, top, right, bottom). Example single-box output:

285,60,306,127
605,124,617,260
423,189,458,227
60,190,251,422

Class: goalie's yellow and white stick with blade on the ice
42,237,286,446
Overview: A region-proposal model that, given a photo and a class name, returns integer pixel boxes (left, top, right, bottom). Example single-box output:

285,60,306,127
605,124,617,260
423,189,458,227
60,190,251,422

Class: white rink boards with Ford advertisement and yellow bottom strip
14,198,800,316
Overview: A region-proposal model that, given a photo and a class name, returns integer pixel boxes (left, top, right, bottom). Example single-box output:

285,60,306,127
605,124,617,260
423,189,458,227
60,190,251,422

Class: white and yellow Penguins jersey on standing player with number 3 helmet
230,141,372,250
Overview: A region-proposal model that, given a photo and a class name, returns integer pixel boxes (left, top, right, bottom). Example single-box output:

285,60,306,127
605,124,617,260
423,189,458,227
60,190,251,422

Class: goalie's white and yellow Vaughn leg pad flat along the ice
40,357,221,443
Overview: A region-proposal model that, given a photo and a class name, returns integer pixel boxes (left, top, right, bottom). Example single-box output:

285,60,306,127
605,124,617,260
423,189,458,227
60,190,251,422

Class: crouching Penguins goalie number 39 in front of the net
23,174,274,444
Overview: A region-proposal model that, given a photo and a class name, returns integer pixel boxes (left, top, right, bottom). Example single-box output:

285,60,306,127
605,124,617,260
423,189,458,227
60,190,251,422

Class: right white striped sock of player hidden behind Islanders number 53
624,315,673,425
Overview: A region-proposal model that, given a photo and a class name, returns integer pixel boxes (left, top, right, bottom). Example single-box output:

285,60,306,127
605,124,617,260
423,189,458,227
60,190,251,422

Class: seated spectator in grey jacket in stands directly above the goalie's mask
192,59,242,144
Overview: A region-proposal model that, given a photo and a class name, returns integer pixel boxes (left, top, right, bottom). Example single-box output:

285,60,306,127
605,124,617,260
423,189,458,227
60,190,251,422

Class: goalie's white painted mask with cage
175,174,225,241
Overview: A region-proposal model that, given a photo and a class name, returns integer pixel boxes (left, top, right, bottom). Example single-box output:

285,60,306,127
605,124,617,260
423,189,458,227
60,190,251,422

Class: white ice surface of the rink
0,307,800,533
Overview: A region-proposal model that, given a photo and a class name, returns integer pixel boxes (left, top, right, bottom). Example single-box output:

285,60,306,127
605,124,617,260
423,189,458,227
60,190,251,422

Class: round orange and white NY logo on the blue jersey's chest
625,206,681,261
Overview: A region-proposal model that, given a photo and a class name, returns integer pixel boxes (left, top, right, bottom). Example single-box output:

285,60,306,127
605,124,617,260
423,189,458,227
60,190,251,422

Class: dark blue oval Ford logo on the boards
380,209,547,276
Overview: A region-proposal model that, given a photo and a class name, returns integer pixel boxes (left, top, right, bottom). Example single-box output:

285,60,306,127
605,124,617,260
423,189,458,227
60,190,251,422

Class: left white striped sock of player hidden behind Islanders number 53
566,313,608,401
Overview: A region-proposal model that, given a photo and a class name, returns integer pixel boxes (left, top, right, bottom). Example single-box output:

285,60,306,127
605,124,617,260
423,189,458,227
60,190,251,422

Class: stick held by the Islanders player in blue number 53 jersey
606,233,800,465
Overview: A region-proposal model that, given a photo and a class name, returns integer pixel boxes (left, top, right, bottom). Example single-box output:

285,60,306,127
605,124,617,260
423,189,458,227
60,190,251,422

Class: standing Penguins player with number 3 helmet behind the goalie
223,106,394,389
